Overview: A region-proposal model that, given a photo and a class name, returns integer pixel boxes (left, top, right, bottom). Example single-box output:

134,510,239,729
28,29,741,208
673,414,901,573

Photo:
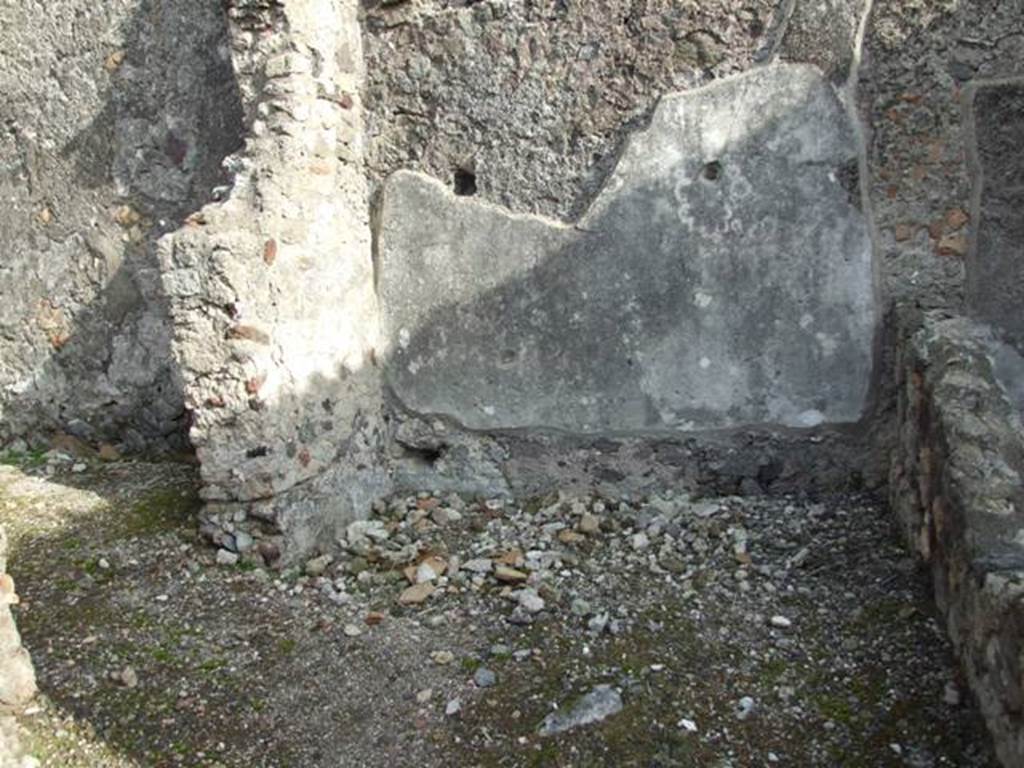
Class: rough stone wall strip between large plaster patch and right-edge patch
858,0,1024,313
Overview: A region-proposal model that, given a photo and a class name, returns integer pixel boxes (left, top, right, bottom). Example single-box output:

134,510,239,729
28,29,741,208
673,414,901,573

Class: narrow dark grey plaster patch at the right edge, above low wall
967,76,1024,349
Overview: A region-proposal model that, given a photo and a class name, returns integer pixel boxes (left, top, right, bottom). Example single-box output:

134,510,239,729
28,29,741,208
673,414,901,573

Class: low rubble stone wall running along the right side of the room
890,313,1024,766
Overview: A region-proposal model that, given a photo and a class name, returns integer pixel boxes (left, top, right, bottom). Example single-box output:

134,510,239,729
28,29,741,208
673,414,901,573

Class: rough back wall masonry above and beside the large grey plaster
0,0,1024,462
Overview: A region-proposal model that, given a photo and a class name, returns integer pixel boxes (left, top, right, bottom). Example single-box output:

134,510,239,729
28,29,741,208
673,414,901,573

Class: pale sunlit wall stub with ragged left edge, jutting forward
159,0,384,561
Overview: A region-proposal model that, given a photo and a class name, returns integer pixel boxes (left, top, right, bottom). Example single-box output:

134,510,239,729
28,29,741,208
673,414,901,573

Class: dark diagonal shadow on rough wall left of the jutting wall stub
0,0,244,453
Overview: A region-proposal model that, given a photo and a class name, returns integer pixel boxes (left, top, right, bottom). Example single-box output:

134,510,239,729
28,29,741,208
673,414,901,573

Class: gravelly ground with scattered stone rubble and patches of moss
0,454,995,768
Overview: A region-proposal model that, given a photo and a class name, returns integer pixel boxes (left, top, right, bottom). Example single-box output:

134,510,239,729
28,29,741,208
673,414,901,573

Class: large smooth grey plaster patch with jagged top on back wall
377,65,876,432
